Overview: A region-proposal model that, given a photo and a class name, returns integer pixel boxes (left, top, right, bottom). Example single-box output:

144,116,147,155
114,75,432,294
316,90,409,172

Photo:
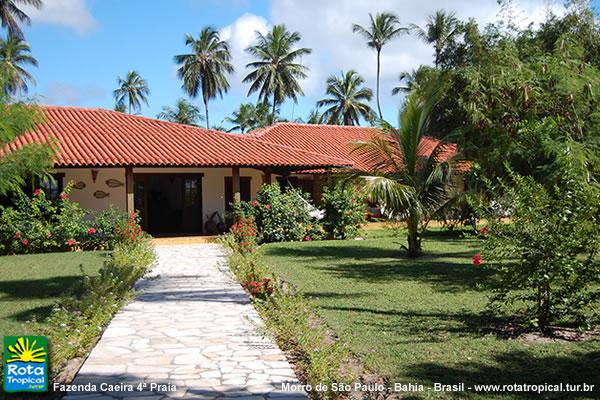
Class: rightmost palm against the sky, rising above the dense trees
410,9,458,68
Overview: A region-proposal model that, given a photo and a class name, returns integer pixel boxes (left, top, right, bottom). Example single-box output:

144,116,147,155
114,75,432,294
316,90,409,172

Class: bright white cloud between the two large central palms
220,13,270,93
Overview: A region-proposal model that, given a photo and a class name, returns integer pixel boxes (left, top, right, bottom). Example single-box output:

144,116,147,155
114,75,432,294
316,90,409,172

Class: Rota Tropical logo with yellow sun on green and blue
4,336,48,393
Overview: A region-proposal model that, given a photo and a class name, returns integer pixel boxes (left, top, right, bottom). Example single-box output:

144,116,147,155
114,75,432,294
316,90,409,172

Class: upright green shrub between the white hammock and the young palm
322,182,366,239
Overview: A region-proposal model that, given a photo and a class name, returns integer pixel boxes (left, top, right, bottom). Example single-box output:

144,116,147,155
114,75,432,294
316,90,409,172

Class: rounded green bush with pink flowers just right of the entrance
240,183,312,242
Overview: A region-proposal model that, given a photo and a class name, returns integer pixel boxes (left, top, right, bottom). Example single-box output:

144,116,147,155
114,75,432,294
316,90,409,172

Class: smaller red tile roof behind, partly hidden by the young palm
250,122,456,171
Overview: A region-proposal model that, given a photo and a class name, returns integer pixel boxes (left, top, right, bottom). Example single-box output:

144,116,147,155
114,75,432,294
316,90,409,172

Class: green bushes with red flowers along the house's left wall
0,188,126,254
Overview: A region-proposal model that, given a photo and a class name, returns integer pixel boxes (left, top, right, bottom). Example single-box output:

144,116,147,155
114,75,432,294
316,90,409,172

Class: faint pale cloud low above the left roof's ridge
37,82,106,106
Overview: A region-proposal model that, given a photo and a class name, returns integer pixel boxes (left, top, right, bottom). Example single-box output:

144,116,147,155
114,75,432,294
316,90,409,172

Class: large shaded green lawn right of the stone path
262,230,600,398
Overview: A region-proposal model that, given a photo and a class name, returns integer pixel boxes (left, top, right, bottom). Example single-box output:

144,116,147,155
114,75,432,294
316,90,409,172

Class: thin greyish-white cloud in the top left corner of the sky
23,0,98,35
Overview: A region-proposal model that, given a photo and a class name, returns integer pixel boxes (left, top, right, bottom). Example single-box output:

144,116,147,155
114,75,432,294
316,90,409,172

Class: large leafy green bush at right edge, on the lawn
474,141,600,331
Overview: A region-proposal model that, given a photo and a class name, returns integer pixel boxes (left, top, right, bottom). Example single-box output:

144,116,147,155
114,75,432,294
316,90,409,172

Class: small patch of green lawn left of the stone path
0,251,107,348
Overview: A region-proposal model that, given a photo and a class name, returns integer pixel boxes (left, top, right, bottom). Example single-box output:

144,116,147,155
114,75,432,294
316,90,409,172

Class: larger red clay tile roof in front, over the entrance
8,106,351,169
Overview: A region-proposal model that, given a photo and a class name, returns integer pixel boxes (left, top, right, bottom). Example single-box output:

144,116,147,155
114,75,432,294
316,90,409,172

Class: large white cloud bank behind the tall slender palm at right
271,0,562,117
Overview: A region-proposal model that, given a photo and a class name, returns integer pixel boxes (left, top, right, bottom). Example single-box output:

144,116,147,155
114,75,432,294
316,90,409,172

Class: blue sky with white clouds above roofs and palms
18,0,600,130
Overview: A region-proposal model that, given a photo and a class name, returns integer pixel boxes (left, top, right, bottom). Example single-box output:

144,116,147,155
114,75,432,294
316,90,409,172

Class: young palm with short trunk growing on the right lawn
356,82,455,257
